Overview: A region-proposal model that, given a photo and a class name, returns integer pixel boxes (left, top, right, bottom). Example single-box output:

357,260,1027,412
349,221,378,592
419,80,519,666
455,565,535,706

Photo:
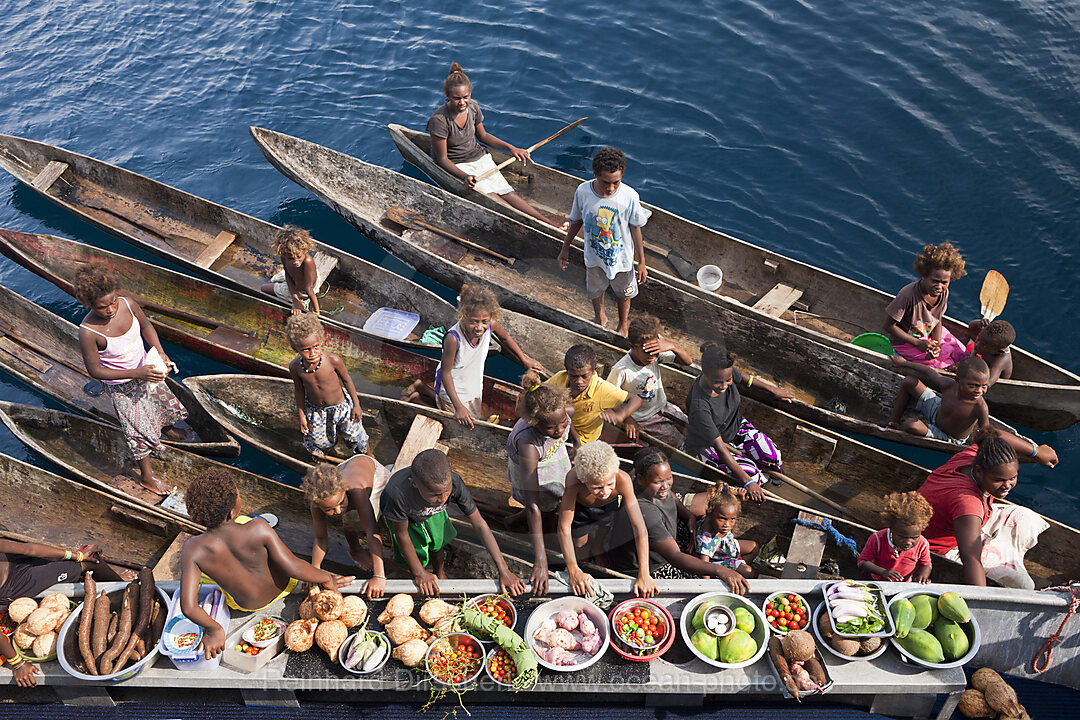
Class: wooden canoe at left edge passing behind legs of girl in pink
0,285,240,458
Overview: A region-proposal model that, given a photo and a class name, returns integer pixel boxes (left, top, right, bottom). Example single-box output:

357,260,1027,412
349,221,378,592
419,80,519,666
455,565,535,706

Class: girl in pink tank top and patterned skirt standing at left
75,264,188,495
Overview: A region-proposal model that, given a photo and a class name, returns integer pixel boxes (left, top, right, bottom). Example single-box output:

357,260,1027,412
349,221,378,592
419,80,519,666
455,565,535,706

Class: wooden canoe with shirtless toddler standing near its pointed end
177,375,902,576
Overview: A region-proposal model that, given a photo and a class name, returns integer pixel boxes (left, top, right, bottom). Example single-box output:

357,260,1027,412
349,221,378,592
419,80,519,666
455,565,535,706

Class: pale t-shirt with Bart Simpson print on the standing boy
570,180,649,277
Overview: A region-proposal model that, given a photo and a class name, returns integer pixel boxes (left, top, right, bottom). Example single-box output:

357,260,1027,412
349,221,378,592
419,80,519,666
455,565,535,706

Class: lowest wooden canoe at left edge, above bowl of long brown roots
0,454,183,580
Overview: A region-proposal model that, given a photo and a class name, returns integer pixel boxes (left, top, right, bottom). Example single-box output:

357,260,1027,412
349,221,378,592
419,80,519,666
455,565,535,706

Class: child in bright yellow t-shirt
548,344,642,445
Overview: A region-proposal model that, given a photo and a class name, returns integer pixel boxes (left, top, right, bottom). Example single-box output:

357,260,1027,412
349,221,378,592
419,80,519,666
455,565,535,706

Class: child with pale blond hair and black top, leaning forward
558,440,657,598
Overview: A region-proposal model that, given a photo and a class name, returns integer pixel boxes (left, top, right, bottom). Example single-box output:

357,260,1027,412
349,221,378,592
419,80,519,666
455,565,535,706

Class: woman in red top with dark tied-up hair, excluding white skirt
919,431,1020,585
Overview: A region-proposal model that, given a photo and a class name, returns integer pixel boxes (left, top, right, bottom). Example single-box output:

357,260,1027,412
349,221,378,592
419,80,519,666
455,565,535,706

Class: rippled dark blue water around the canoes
0,0,1080,521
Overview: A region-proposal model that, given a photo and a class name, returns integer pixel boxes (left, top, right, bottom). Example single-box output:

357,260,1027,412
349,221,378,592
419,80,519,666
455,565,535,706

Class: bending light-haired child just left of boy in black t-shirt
300,462,389,599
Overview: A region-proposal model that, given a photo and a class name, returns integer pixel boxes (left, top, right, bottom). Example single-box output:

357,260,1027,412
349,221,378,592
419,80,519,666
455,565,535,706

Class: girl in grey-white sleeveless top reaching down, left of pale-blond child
505,370,573,595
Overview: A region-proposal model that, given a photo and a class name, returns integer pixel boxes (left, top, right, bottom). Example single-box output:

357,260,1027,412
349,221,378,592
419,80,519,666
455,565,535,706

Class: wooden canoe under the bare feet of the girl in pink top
0,400,352,568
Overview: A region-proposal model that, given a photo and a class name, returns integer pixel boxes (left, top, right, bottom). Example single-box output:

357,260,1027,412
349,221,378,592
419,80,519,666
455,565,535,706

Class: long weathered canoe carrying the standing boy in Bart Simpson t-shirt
251,122,1019,452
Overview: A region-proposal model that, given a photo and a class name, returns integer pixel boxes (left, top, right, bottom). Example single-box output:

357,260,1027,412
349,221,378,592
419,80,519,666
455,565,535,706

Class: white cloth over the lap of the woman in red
945,503,1050,590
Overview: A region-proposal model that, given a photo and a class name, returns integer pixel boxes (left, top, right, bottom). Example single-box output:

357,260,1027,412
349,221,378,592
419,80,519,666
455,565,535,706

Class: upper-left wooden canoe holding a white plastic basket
0,135,457,350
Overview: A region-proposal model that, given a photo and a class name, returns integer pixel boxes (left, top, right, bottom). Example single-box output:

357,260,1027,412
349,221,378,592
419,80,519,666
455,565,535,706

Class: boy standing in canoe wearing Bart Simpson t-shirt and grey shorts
558,147,649,337
